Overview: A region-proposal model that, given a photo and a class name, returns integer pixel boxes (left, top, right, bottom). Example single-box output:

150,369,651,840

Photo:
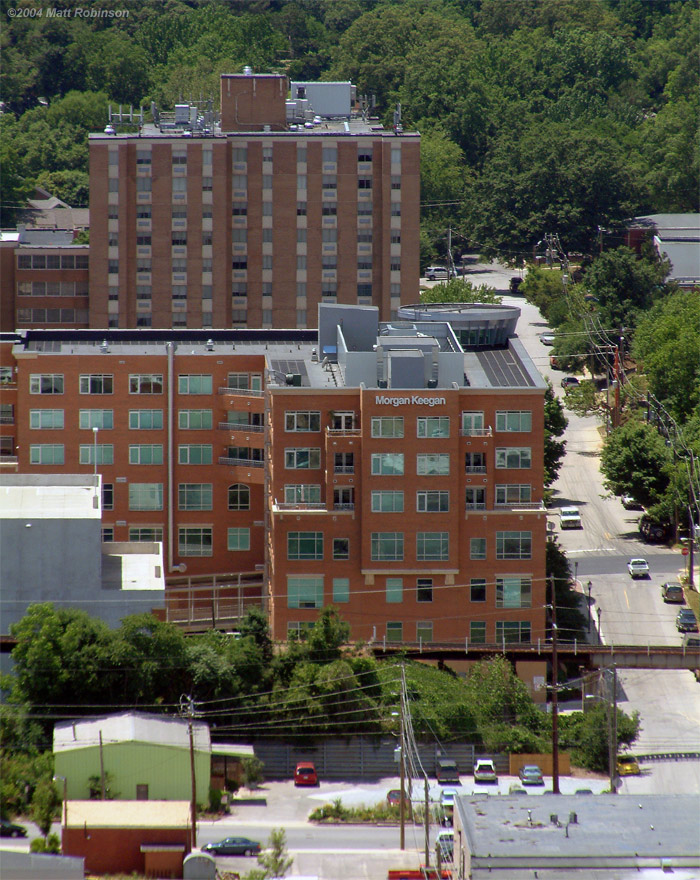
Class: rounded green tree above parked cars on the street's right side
600,419,670,507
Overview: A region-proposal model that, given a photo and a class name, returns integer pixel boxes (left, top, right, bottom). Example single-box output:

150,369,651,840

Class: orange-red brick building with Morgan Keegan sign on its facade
2,304,546,642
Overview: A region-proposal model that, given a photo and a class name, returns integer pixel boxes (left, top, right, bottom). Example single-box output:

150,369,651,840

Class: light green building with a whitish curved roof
53,712,211,804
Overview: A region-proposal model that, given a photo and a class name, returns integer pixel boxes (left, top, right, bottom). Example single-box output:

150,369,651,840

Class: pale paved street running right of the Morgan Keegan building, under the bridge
505,297,700,794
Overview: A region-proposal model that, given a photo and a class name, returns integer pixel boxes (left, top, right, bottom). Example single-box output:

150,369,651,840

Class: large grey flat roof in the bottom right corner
455,794,700,869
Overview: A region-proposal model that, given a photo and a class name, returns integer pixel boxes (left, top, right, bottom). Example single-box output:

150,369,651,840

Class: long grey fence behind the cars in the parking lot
253,736,508,779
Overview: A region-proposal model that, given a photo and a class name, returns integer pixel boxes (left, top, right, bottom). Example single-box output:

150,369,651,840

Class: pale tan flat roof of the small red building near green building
66,800,190,829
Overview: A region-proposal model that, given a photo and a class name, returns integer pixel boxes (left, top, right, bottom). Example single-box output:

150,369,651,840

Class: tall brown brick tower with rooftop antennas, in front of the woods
85,73,420,328
